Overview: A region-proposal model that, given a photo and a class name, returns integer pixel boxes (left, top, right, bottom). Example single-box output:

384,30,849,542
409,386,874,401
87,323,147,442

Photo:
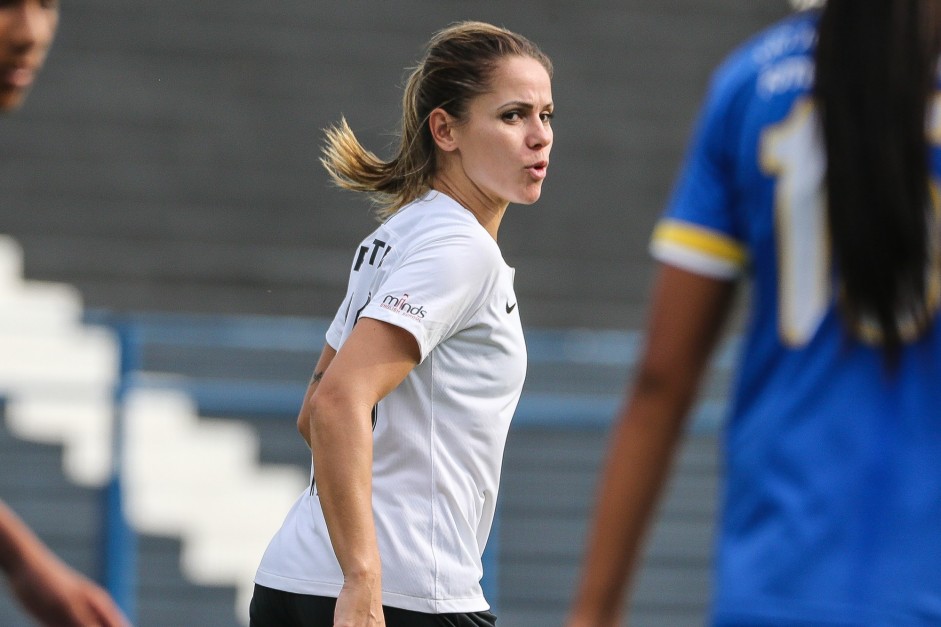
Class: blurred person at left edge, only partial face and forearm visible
0,0,126,627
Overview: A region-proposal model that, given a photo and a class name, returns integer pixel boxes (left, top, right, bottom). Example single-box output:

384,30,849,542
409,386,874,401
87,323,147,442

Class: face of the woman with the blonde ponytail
454,56,553,205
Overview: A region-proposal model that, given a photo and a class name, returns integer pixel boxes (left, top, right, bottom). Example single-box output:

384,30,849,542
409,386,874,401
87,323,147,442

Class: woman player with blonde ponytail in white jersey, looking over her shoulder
251,22,553,627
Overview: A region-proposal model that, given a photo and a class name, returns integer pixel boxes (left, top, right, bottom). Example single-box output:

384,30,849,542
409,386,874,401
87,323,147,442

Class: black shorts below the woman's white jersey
248,583,497,627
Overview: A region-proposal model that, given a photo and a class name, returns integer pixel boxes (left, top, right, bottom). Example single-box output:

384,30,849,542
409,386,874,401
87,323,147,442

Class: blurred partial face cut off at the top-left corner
0,0,59,112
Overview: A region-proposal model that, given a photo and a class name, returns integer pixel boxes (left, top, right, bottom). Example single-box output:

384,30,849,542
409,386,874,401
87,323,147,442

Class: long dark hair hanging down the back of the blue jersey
815,0,941,358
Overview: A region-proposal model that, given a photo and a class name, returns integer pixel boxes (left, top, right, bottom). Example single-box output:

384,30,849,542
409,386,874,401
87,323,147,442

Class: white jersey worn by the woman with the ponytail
255,191,526,613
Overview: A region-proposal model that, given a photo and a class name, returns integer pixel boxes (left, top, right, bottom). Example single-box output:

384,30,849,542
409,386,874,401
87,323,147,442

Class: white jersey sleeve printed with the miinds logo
360,233,501,360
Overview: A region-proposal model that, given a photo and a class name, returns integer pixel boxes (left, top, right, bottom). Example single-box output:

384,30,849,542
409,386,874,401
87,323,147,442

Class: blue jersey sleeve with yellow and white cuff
650,59,747,279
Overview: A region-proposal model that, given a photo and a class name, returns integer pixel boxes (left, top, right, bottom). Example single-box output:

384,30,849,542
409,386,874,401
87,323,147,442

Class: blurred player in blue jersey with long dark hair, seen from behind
568,0,941,627
